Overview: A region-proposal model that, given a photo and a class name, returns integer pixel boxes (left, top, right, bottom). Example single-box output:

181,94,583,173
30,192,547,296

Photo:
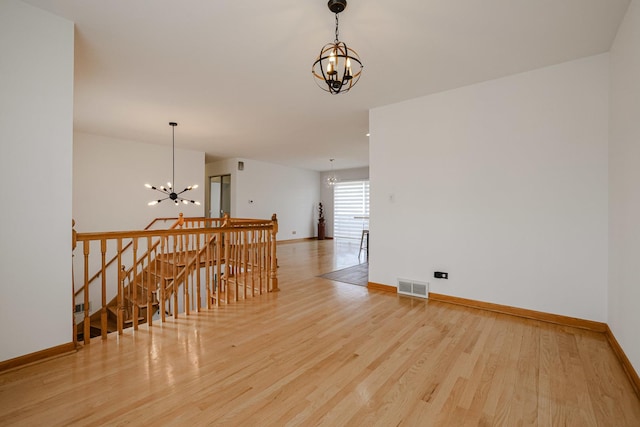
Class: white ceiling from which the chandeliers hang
24,0,629,170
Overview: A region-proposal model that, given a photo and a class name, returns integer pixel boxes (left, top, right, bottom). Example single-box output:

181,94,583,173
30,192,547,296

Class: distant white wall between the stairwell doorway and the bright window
207,159,320,240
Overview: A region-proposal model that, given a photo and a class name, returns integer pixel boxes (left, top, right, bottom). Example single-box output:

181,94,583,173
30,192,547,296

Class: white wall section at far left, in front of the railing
0,0,73,361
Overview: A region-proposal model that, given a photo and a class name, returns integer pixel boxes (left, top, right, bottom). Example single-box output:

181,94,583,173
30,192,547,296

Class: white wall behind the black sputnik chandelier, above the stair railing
73,131,205,232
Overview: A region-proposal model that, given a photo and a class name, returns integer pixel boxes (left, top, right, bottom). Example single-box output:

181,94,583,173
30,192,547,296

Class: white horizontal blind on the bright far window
333,181,369,239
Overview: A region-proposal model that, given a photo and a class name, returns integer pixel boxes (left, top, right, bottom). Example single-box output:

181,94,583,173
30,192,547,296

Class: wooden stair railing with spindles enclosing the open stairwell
73,214,278,344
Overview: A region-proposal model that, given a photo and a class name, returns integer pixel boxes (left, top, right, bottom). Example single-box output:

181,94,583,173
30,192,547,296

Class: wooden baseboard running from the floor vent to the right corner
429,292,607,333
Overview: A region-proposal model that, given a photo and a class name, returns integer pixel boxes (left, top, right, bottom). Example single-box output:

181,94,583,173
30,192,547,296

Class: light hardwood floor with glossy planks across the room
0,240,640,427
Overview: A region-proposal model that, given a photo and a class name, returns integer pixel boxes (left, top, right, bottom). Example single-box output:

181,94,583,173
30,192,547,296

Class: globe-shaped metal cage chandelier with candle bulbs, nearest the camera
311,0,363,95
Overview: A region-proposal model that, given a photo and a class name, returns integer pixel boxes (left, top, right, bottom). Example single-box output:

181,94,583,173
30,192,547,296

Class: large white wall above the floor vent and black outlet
369,54,609,321
